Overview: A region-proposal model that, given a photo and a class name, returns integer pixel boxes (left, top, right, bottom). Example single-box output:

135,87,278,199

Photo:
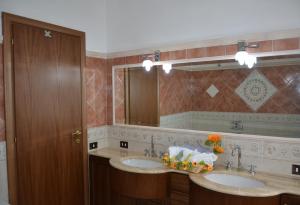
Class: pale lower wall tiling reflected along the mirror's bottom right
160,111,300,138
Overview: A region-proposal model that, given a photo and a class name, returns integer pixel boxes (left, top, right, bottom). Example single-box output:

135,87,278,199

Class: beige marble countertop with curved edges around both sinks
89,148,300,197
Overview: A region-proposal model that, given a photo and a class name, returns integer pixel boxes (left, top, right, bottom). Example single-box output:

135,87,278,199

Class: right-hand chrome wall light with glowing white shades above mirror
235,41,259,68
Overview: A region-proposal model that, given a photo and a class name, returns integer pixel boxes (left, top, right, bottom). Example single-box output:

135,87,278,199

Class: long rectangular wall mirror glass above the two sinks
113,55,300,138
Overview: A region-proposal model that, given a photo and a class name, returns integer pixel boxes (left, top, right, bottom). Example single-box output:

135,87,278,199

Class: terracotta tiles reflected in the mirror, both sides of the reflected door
115,65,300,116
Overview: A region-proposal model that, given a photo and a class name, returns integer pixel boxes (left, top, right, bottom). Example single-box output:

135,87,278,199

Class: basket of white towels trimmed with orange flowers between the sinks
162,134,224,173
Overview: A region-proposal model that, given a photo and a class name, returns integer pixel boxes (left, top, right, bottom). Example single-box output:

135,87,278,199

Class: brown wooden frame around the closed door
2,12,89,205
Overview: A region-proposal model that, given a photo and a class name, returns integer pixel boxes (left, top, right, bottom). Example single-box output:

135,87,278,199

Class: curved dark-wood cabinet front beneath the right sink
190,182,282,205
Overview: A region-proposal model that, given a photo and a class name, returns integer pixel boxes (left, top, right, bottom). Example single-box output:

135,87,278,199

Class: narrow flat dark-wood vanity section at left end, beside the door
90,156,110,205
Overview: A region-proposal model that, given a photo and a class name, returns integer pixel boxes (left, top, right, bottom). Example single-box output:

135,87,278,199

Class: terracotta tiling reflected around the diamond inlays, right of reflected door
191,65,300,114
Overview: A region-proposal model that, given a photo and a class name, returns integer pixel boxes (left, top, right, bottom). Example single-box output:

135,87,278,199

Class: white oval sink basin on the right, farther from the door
204,174,265,188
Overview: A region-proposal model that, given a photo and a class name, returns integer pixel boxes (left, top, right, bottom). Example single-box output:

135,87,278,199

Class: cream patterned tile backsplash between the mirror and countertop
89,125,300,177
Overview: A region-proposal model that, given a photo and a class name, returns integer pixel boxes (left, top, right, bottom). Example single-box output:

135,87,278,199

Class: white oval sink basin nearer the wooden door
122,159,164,169
